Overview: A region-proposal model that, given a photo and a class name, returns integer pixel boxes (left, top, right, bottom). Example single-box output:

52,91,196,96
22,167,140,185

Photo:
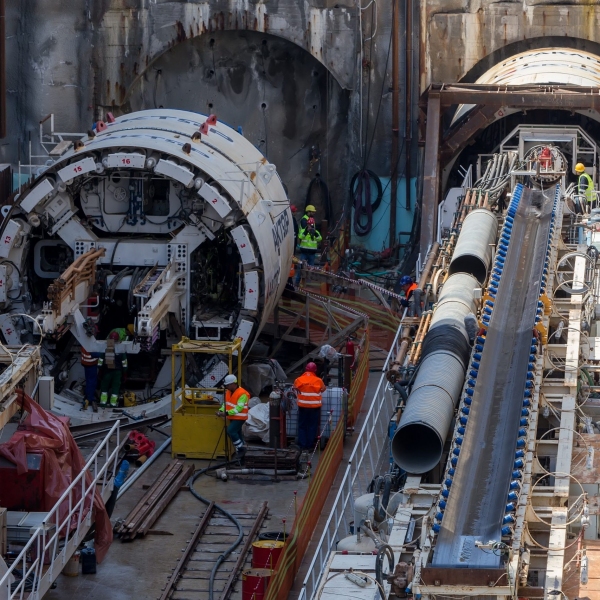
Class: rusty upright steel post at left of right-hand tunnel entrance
420,92,441,260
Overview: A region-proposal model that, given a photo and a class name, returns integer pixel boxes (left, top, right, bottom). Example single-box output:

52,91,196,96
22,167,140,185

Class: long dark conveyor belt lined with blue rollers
433,189,554,567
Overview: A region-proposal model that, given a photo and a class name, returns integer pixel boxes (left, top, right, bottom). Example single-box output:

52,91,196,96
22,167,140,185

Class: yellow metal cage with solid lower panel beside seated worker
171,337,242,459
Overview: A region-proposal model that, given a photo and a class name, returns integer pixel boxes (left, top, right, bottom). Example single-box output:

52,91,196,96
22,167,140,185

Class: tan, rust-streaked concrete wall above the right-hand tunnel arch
419,0,600,92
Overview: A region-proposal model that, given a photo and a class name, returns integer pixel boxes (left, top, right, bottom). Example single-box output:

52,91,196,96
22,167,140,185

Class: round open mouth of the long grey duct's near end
392,423,444,474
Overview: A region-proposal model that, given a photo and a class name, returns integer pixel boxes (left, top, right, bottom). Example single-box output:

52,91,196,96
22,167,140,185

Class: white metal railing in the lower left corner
0,421,119,600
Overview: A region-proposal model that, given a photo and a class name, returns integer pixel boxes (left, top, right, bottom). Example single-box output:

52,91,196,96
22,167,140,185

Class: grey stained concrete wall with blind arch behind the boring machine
0,0,418,241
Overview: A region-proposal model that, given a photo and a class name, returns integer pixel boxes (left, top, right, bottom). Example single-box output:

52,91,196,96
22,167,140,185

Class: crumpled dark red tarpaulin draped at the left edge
0,390,113,562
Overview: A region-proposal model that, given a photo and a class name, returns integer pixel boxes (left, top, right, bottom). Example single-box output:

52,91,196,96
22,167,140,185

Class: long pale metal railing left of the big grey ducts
298,326,402,600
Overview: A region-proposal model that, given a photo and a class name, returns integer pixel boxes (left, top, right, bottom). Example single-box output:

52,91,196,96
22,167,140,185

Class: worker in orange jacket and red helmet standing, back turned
294,362,327,450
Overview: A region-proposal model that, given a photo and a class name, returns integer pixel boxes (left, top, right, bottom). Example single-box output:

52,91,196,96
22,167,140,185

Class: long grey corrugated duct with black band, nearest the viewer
392,273,480,473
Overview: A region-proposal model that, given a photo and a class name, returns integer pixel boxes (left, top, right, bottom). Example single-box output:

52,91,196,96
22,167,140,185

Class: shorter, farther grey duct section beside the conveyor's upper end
448,208,498,285
